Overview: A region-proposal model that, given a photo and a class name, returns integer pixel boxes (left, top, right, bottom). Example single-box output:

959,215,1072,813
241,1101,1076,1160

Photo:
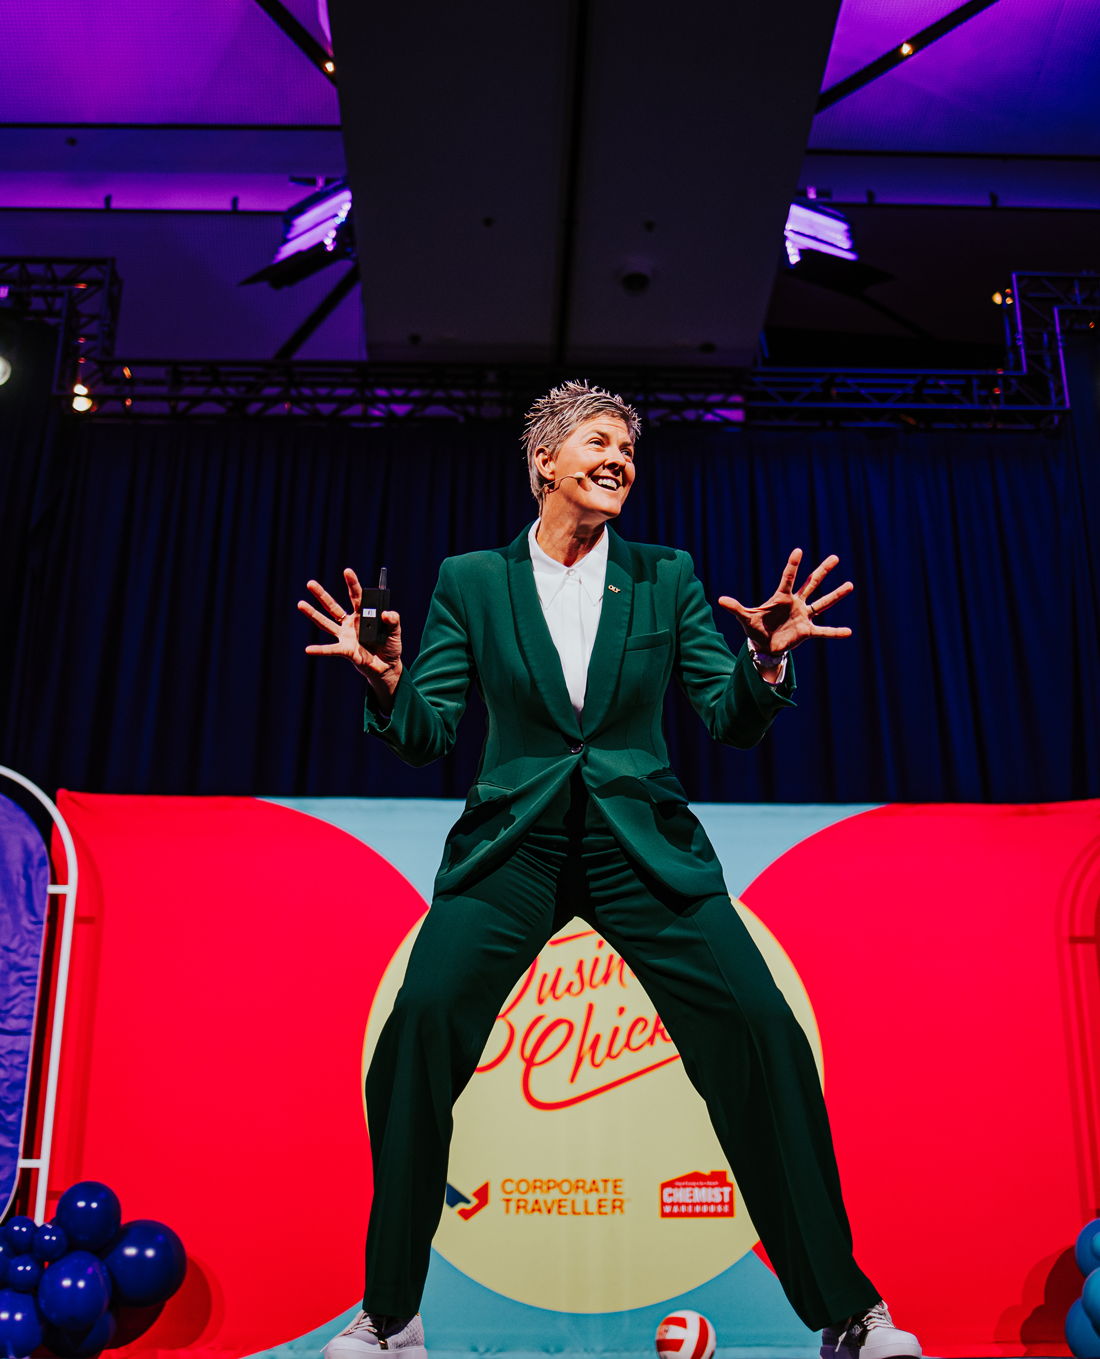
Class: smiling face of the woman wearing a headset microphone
534,416,634,526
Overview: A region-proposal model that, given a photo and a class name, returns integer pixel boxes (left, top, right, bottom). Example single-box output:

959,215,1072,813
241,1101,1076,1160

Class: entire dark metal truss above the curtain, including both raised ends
0,257,1100,429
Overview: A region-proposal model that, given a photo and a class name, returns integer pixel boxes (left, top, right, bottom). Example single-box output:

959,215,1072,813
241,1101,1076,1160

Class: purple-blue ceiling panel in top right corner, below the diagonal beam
809,0,1100,155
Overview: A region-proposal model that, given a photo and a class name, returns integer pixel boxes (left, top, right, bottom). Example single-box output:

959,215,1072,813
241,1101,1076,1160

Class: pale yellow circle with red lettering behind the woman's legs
363,901,824,1311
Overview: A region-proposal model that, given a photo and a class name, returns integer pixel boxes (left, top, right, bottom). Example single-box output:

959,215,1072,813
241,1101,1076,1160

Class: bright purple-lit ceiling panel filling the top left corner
0,0,340,125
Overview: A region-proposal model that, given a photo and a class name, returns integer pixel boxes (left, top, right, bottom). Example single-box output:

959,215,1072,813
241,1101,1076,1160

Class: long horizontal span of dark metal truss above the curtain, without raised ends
75,359,1065,429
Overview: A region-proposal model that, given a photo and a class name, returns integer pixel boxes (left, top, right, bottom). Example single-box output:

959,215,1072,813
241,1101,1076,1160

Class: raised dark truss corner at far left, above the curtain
0,255,122,393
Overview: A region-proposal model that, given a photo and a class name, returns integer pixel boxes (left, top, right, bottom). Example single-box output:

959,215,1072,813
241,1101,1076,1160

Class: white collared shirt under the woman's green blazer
528,520,608,716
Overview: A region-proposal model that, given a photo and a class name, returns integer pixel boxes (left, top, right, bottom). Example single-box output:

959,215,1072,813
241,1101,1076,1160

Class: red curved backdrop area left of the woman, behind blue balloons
50,794,424,1355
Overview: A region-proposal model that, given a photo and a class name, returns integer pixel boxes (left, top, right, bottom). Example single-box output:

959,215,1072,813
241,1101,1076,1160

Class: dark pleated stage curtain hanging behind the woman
0,342,1100,802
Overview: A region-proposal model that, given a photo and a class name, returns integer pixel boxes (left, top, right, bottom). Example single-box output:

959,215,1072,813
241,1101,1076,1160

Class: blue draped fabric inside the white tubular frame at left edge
0,796,50,1214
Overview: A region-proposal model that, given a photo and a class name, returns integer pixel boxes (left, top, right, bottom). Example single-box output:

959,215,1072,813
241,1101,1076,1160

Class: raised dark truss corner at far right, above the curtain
1006,273,1100,408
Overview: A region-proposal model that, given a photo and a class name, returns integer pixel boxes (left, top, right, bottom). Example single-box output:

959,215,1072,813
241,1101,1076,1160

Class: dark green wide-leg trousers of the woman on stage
363,779,880,1330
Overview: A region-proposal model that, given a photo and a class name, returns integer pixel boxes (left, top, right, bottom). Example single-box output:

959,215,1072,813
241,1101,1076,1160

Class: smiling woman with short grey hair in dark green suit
299,383,921,1359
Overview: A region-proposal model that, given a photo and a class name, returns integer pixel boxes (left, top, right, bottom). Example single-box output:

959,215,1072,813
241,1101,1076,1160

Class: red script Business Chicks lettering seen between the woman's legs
477,930,680,1110
